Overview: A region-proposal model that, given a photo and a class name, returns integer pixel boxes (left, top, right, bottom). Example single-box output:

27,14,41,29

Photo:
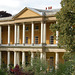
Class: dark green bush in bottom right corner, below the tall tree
55,61,75,75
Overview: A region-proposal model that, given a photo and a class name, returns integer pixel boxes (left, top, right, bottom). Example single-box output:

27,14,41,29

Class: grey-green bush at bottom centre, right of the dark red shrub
25,54,48,75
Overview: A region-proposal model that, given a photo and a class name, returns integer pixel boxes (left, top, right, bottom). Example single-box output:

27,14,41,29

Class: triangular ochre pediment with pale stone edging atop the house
14,8,40,18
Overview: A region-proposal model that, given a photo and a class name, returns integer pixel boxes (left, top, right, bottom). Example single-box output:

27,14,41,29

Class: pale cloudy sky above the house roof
0,0,61,15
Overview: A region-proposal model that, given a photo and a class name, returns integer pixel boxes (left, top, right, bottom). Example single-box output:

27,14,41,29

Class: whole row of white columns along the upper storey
0,22,58,45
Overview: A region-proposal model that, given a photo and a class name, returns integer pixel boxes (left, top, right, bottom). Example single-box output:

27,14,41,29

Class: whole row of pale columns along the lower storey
0,51,59,69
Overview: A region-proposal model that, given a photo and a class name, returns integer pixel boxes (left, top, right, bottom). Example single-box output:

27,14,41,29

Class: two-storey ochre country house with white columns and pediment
0,7,65,68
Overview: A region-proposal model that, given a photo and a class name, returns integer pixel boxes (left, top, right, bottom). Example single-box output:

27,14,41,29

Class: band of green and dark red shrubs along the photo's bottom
1,54,75,75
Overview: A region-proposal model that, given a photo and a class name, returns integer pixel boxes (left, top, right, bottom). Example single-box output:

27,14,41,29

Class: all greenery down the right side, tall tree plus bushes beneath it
50,0,75,75
